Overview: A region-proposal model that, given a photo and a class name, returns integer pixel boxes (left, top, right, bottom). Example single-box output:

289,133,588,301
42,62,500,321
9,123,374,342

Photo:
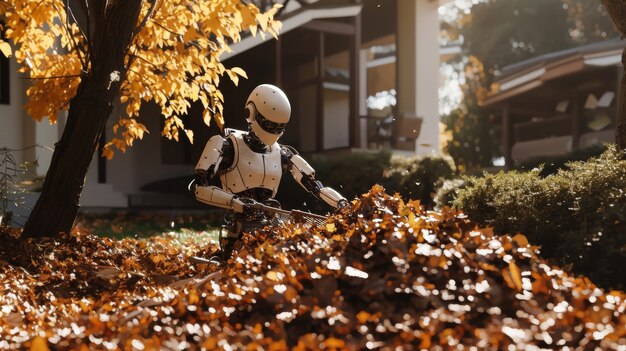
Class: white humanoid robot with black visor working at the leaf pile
190,84,348,259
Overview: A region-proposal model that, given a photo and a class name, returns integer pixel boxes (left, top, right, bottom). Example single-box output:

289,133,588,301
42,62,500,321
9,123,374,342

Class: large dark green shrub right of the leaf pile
455,146,626,289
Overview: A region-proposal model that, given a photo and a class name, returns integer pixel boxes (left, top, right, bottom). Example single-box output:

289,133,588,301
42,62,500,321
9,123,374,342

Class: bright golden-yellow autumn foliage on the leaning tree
0,0,280,158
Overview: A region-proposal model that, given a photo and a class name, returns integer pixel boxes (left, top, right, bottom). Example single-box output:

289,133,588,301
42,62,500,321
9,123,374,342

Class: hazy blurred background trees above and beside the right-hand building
442,0,618,171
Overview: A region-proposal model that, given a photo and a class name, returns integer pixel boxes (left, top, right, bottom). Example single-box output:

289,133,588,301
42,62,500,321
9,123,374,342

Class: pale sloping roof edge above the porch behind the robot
220,4,362,60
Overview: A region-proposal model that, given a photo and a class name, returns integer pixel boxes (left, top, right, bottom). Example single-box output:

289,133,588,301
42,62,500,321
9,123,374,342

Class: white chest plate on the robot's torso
220,130,282,197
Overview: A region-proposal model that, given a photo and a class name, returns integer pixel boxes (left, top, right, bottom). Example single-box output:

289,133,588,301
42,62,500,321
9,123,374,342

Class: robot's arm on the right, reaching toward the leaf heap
289,154,348,208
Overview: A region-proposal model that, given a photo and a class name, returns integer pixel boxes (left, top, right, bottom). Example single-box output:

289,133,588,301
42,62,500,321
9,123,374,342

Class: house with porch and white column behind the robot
0,0,443,207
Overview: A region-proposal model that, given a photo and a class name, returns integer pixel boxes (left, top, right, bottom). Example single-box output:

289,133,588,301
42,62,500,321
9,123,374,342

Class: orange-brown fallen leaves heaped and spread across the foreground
0,187,626,350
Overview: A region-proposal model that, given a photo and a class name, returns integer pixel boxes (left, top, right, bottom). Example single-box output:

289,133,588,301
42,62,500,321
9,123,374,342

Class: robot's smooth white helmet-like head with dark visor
246,84,291,146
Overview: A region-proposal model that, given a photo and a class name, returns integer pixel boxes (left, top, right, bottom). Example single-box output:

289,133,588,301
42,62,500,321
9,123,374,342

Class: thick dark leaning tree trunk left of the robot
22,0,143,238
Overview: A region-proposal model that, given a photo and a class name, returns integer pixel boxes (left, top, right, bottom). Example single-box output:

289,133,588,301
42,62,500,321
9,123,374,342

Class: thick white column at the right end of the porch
396,0,439,154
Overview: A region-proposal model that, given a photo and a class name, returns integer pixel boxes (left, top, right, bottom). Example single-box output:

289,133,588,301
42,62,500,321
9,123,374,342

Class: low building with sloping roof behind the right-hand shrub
484,39,626,166
